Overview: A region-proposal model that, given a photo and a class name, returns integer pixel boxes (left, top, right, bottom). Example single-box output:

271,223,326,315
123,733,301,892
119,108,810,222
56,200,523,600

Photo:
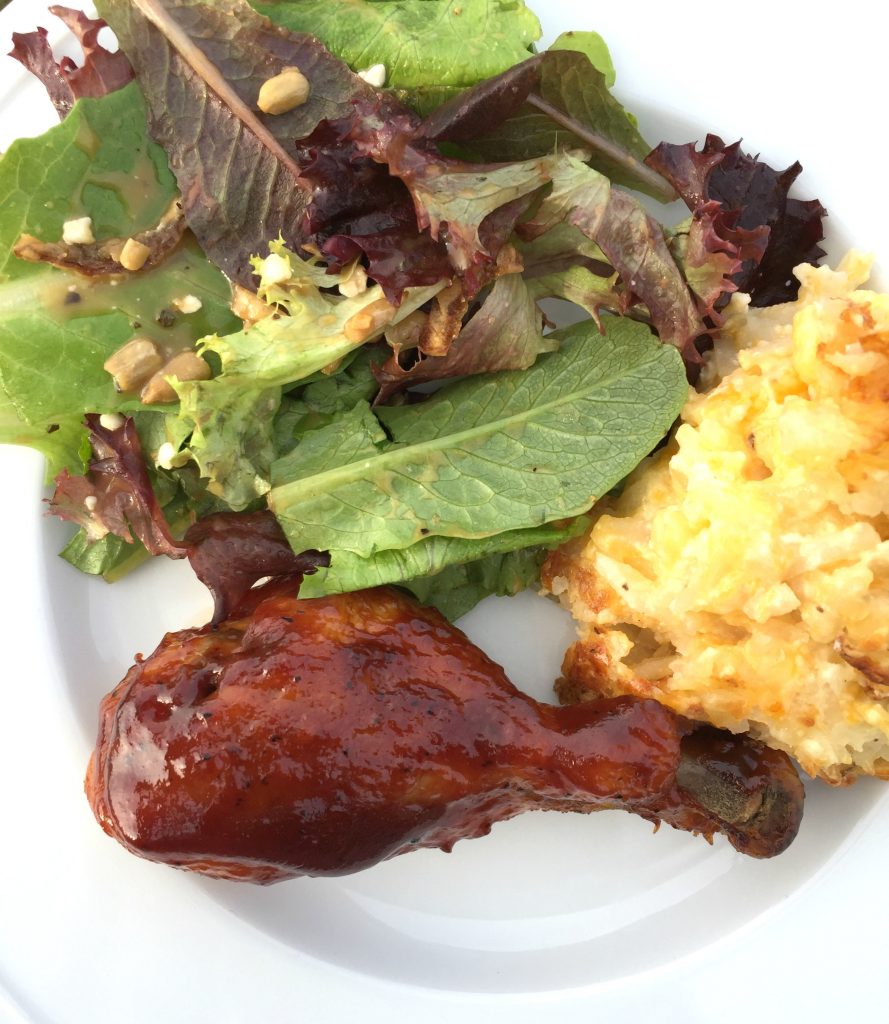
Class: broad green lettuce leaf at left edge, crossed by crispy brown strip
0,84,239,439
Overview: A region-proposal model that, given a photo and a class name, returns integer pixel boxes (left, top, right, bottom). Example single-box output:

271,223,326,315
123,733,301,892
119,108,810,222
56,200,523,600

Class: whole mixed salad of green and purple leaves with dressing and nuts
0,0,824,617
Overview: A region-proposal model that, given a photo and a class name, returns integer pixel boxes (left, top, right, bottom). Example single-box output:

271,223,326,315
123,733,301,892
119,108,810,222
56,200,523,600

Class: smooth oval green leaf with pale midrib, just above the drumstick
268,319,687,557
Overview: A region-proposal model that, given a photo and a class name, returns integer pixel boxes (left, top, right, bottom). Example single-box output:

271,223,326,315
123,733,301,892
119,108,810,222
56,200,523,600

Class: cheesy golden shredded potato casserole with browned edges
543,253,889,783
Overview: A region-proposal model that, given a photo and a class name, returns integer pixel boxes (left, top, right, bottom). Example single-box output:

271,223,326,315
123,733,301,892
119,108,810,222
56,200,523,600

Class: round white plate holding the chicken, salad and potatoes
0,0,889,1024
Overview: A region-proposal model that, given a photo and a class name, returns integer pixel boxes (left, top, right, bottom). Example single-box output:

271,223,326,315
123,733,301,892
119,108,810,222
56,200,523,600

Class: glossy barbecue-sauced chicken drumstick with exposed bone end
86,578,803,883
